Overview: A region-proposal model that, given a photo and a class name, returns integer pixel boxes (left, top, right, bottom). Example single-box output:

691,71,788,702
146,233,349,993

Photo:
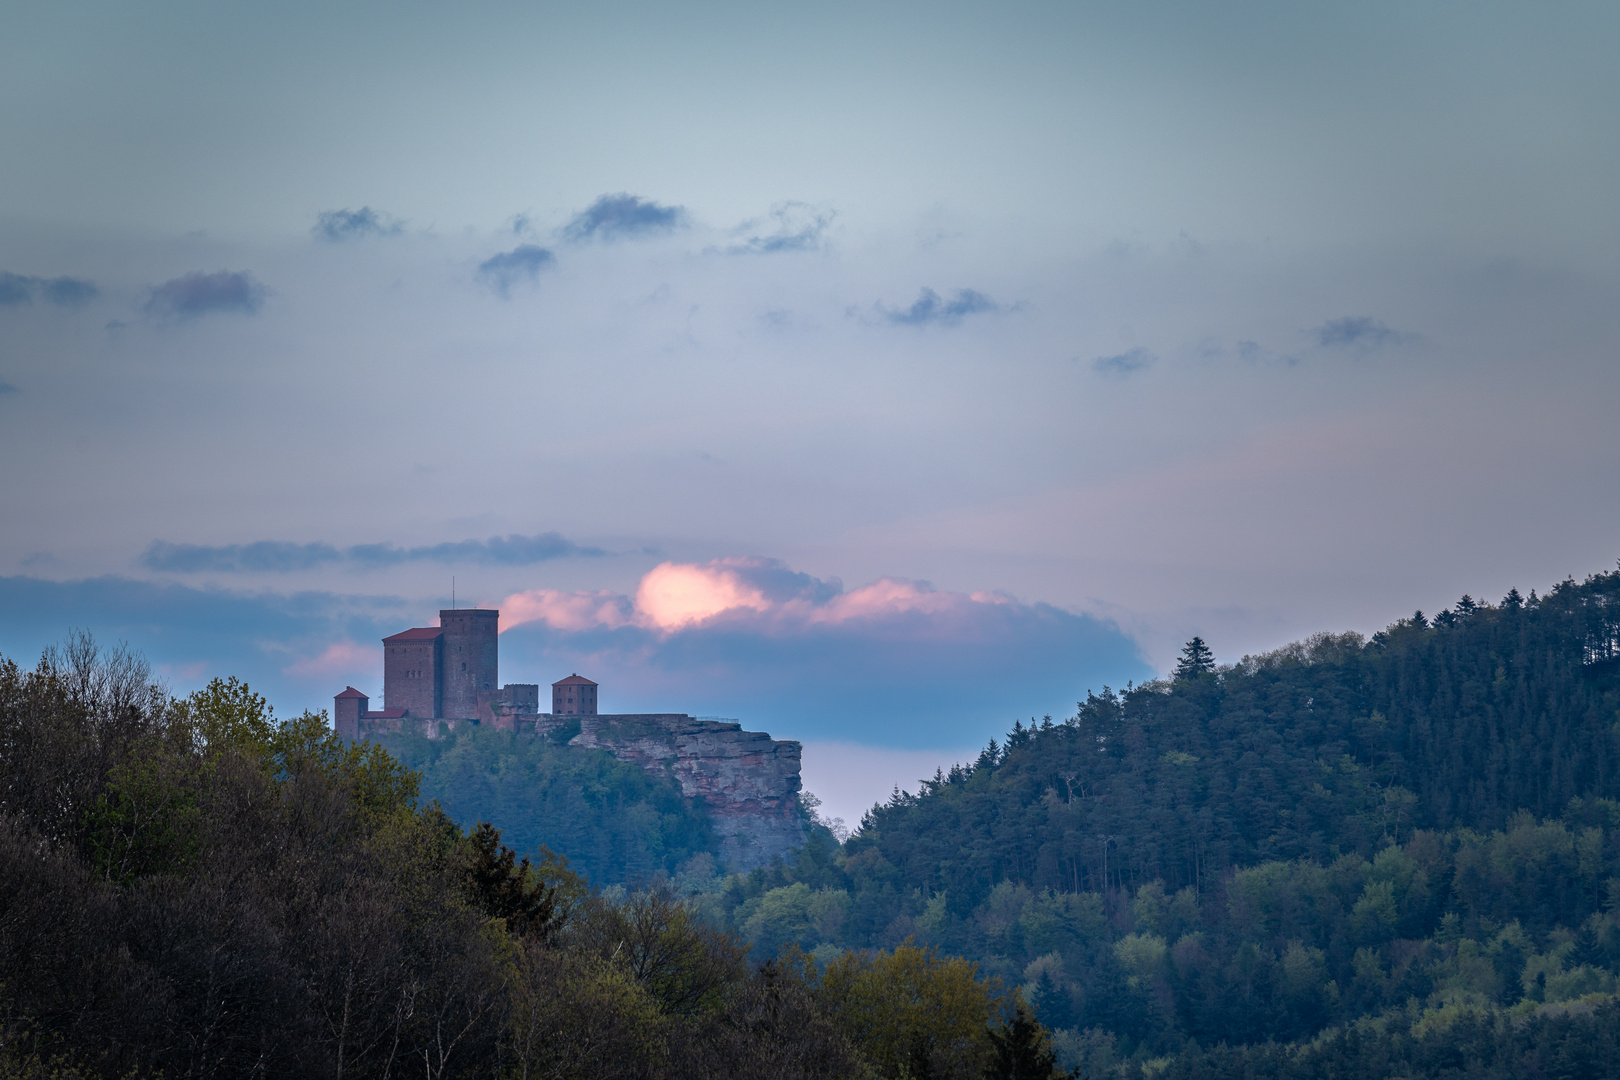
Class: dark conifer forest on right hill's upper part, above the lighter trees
847,572,1620,913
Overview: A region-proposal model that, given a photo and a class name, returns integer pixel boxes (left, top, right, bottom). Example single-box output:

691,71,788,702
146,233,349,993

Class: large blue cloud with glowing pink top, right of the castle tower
499,557,1152,746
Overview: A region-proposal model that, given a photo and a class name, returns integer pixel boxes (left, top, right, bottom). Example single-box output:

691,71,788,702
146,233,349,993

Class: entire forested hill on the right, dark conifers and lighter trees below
703,573,1620,1080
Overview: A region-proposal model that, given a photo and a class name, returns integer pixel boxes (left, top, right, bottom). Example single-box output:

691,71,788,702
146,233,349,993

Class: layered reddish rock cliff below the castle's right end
547,712,805,870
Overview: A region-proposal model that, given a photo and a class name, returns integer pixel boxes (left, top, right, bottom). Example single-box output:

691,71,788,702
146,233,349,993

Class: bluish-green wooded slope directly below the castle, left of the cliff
375,729,719,884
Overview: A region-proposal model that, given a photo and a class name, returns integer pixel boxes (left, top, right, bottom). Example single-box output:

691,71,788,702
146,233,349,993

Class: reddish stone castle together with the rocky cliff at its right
332,607,805,870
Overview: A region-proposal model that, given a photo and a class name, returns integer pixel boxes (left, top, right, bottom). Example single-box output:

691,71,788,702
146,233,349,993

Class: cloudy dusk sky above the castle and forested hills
0,0,1620,821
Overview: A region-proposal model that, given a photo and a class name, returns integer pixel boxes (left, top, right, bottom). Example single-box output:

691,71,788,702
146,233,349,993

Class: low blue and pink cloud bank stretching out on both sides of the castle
0,559,1152,748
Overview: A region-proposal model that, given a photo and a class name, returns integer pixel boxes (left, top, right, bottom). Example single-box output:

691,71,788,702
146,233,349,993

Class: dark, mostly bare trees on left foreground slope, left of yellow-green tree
0,640,900,1080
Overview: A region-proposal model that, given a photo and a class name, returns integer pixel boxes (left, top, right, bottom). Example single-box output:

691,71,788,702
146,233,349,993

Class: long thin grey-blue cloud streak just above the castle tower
139,533,608,573
